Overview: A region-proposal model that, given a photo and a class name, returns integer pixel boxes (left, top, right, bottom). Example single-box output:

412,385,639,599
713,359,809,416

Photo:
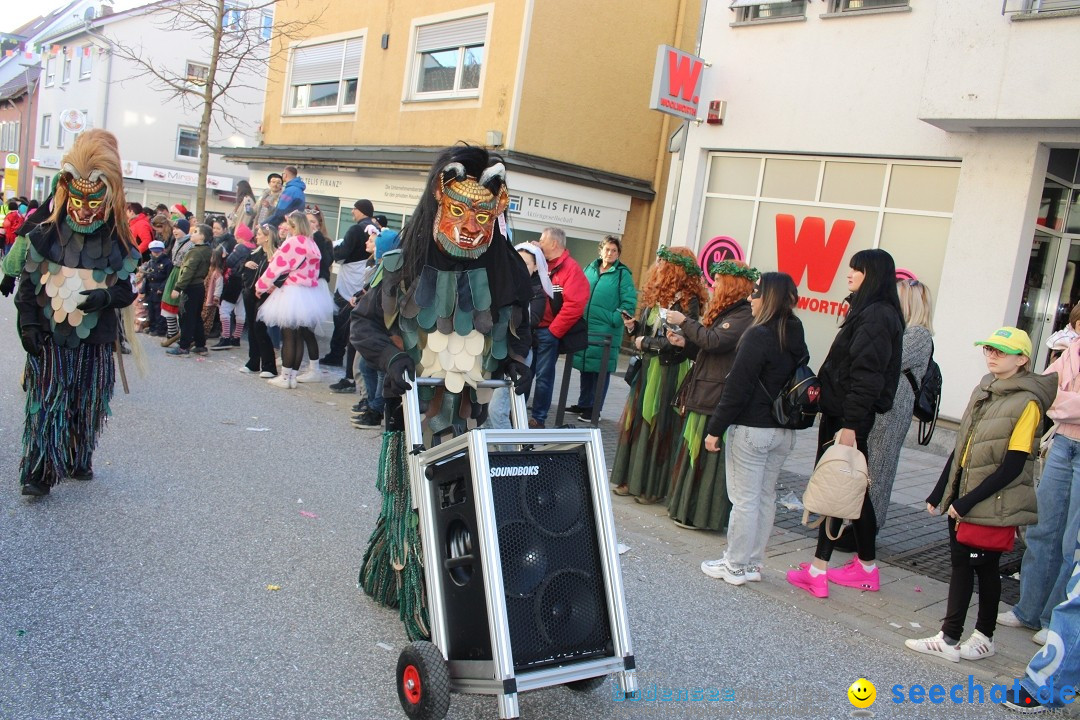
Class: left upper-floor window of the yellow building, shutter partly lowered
288,37,364,113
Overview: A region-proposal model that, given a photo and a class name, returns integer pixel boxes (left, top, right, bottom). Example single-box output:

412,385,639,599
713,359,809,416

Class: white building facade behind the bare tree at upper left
31,3,269,212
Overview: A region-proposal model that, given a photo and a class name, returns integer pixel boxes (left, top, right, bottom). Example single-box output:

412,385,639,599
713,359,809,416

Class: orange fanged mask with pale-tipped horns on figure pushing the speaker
434,162,510,259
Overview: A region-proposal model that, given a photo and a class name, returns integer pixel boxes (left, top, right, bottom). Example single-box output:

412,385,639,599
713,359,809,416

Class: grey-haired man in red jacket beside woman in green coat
529,228,589,427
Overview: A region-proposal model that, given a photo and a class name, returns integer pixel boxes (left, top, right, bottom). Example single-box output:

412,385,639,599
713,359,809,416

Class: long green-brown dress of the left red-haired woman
611,298,698,503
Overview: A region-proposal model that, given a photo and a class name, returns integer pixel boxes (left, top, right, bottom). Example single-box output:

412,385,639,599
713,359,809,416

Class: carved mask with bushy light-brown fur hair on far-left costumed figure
55,130,126,233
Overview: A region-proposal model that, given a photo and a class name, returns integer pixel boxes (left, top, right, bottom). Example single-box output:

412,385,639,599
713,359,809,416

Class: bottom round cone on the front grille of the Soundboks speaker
536,569,600,648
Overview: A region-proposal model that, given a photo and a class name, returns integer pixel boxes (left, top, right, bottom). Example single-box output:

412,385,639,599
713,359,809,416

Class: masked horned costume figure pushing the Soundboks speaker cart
350,146,531,640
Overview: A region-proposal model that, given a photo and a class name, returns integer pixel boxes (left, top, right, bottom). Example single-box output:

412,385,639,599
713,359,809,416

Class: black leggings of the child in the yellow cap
942,518,1001,640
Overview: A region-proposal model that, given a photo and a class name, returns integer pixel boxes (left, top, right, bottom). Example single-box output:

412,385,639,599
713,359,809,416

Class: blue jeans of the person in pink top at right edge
1013,435,1080,628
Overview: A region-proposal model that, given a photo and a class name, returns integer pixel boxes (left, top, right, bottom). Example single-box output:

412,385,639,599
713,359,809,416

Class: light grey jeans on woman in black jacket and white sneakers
725,425,795,568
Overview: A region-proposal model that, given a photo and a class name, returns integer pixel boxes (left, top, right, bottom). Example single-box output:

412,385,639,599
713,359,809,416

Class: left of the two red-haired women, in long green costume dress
611,245,708,504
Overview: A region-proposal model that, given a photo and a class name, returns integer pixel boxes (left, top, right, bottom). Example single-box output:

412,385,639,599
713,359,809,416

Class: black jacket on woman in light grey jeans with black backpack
707,316,809,437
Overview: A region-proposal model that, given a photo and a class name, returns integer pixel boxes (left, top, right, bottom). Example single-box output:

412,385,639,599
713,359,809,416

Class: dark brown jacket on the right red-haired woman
675,300,754,415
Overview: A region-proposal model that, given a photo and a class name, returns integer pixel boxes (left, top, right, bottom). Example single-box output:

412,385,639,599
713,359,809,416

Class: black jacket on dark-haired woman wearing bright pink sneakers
818,300,904,430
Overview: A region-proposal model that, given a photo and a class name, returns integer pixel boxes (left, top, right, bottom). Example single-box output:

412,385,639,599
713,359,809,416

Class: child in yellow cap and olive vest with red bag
904,327,1057,663
